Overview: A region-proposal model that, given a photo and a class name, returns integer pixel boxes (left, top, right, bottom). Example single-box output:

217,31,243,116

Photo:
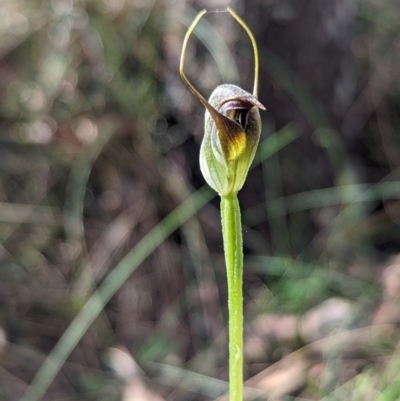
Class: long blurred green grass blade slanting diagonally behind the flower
20,130,297,401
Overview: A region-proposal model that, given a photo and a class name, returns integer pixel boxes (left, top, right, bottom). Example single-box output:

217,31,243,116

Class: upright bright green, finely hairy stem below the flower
221,193,243,401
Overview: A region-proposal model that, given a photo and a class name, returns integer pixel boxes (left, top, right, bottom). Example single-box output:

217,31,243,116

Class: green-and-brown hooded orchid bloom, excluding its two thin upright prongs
200,85,265,196
